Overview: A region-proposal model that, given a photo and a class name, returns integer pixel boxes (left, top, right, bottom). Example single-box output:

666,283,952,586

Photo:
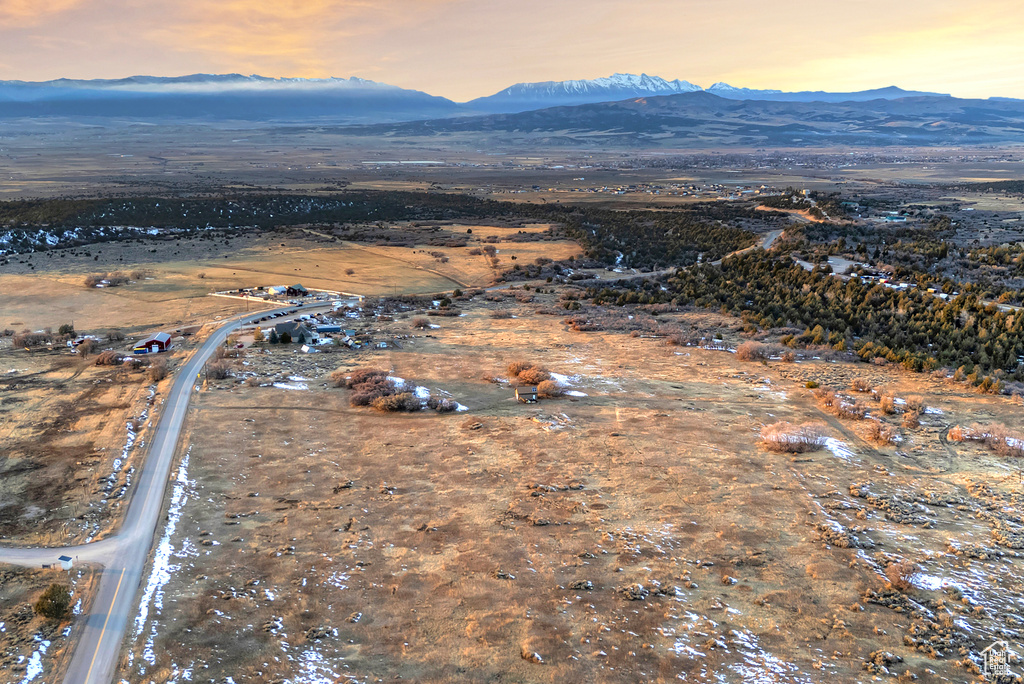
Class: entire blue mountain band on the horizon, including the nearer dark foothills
0,74,1024,146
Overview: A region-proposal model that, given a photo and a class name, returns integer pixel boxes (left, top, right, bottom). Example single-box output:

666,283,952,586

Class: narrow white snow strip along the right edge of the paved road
134,446,196,666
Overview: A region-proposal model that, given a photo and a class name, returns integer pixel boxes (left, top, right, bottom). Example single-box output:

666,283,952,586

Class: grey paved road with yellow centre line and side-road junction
0,304,330,684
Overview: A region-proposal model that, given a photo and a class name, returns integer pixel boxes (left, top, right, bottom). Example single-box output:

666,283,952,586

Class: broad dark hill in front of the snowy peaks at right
337,91,1024,147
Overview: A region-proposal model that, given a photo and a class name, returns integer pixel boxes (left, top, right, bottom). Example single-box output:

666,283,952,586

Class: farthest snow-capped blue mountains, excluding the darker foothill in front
0,74,966,123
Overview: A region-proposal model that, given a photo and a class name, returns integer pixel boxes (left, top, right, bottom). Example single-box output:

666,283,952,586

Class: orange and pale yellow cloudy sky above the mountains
0,0,1024,101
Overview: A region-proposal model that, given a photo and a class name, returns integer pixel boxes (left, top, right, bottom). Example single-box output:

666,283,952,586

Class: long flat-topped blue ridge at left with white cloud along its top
0,74,463,123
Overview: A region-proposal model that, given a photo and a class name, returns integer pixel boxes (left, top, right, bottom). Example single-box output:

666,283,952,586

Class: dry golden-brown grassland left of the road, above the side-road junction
0,225,580,545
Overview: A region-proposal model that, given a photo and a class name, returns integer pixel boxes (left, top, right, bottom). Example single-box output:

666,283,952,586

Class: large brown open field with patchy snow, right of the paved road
121,295,1024,682
